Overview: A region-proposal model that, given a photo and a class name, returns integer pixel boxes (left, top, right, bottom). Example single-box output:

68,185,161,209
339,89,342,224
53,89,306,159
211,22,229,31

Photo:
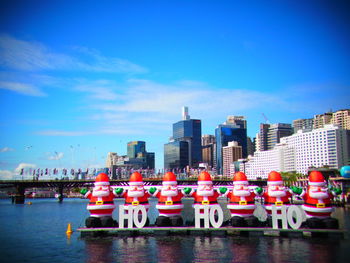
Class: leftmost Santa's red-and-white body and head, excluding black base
84,173,115,217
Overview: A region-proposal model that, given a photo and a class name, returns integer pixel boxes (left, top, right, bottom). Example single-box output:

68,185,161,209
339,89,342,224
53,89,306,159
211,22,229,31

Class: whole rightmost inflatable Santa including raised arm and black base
300,171,341,228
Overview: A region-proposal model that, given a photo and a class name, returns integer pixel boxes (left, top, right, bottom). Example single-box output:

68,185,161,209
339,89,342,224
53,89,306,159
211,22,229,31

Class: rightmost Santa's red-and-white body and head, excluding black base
301,171,334,218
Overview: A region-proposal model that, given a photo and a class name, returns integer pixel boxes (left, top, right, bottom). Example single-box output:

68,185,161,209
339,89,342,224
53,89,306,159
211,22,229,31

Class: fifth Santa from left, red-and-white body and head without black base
227,172,256,217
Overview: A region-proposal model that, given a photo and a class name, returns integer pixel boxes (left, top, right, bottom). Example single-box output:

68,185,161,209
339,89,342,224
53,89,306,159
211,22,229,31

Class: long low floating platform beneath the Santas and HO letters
76,227,345,239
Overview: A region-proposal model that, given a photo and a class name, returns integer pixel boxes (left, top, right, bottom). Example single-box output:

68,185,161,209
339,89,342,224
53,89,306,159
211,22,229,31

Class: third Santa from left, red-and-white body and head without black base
154,172,184,217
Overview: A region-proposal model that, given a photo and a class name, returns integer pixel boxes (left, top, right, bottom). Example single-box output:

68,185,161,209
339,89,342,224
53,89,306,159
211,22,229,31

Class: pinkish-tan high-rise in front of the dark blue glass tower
222,141,242,176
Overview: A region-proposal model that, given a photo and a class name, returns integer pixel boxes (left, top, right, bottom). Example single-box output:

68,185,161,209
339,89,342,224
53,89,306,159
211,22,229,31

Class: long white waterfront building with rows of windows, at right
240,124,350,179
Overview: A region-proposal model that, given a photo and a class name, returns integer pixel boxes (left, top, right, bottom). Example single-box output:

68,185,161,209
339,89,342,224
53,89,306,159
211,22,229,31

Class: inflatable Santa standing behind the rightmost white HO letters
263,171,292,226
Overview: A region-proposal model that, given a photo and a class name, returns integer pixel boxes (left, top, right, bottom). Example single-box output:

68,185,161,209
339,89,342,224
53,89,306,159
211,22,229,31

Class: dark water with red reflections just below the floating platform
84,236,346,263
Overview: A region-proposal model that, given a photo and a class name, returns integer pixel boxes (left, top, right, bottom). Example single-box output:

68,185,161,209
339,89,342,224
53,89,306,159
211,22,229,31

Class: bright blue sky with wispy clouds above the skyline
0,0,350,179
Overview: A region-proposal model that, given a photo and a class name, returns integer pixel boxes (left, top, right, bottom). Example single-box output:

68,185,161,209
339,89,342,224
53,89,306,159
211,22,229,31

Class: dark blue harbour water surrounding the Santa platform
0,198,350,263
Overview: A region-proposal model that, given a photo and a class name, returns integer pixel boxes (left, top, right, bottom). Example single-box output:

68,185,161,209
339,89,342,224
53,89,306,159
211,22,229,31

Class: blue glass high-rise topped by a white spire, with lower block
164,107,202,168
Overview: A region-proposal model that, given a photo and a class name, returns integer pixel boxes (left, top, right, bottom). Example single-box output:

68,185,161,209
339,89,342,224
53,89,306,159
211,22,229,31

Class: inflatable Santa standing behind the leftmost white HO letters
115,172,150,225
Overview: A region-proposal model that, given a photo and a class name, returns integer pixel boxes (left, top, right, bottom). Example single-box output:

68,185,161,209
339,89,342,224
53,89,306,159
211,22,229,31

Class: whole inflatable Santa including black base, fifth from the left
227,172,262,227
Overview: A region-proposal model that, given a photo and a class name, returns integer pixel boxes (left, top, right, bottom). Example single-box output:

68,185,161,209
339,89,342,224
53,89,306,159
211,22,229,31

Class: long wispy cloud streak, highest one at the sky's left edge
0,35,147,73
